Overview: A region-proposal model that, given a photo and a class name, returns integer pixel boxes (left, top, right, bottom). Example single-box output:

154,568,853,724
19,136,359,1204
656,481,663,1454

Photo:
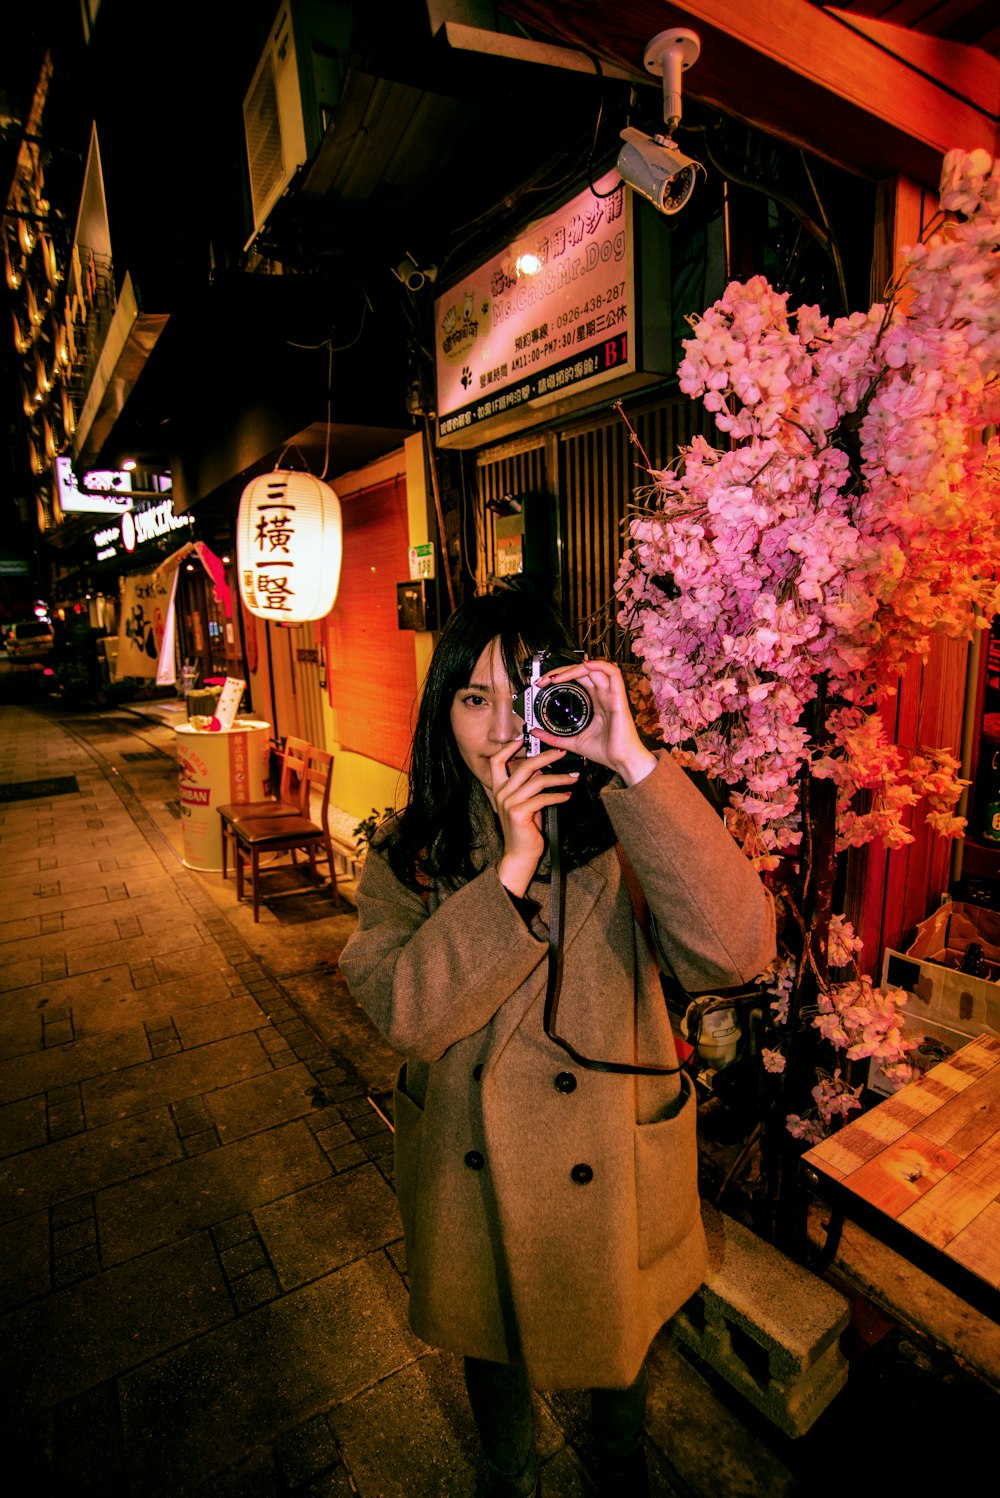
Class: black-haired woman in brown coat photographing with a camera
341,592,774,1498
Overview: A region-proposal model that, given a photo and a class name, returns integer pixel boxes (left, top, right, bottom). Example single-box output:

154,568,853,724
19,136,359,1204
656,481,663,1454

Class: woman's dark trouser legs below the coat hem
466,1357,650,1498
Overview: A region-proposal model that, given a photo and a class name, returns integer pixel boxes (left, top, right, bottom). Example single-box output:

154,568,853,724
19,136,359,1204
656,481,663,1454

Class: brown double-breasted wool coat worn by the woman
340,753,774,1389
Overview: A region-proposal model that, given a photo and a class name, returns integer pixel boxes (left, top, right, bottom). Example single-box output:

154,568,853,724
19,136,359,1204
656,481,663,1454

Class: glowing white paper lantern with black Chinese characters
237,469,343,625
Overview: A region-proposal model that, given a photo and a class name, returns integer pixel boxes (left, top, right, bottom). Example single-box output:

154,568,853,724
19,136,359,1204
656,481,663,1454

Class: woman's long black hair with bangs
386,590,615,887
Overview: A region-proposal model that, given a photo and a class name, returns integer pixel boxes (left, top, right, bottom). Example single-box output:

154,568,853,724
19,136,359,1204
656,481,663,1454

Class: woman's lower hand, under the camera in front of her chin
490,740,579,896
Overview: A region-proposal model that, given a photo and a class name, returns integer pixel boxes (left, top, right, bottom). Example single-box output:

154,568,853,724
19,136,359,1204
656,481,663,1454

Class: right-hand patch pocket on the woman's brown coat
635,1073,699,1269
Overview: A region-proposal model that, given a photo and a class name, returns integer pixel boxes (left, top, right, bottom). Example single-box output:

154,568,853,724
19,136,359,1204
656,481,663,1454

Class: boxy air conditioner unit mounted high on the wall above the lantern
243,0,350,249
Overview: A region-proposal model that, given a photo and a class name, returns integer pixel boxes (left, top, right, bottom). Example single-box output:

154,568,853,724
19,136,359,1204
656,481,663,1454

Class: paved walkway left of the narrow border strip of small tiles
0,707,452,1495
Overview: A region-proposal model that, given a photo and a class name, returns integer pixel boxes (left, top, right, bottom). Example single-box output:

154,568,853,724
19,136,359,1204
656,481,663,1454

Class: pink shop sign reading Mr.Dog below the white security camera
434,171,671,446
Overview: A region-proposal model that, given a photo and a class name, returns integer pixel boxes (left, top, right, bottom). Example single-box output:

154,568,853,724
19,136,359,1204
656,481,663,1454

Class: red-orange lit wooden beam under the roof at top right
500,0,1000,187
